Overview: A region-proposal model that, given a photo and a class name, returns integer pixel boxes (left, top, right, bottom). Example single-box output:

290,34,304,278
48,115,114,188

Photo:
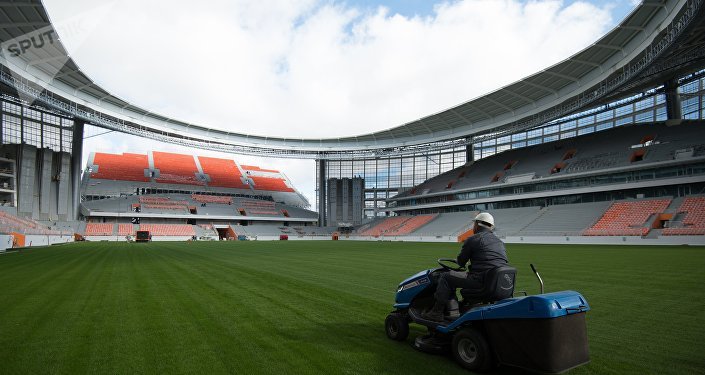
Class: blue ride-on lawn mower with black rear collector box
385,258,590,374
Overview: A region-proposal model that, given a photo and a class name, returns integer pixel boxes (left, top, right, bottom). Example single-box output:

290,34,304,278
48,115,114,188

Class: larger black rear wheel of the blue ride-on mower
451,327,492,372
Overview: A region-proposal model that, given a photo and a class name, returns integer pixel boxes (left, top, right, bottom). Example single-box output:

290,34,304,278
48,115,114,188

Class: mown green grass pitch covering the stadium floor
0,241,705,374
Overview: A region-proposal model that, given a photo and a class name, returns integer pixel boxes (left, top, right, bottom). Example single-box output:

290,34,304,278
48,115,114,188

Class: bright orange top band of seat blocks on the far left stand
91,151,295,192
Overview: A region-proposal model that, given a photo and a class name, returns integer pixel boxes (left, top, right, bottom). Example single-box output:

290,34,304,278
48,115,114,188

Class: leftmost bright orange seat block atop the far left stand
91,152,150,182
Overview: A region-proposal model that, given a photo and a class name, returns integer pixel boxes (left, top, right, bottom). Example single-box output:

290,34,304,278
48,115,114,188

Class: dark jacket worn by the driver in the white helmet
458,227,508,273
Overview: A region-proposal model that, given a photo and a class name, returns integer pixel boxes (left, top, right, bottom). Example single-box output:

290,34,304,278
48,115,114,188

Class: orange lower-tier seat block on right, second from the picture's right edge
583,199,671,236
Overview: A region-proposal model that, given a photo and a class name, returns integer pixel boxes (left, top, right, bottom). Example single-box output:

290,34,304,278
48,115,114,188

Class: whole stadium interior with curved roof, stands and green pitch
0,0,705,374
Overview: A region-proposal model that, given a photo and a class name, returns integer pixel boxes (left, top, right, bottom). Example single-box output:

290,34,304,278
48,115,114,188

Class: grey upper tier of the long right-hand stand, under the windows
395,121,705,199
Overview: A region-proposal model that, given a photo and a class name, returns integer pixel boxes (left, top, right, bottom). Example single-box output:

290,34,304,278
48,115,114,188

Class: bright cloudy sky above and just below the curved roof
44,0,638,209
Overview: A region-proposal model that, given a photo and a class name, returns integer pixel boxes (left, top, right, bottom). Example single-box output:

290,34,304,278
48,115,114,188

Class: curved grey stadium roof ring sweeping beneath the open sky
0,0,705,158
